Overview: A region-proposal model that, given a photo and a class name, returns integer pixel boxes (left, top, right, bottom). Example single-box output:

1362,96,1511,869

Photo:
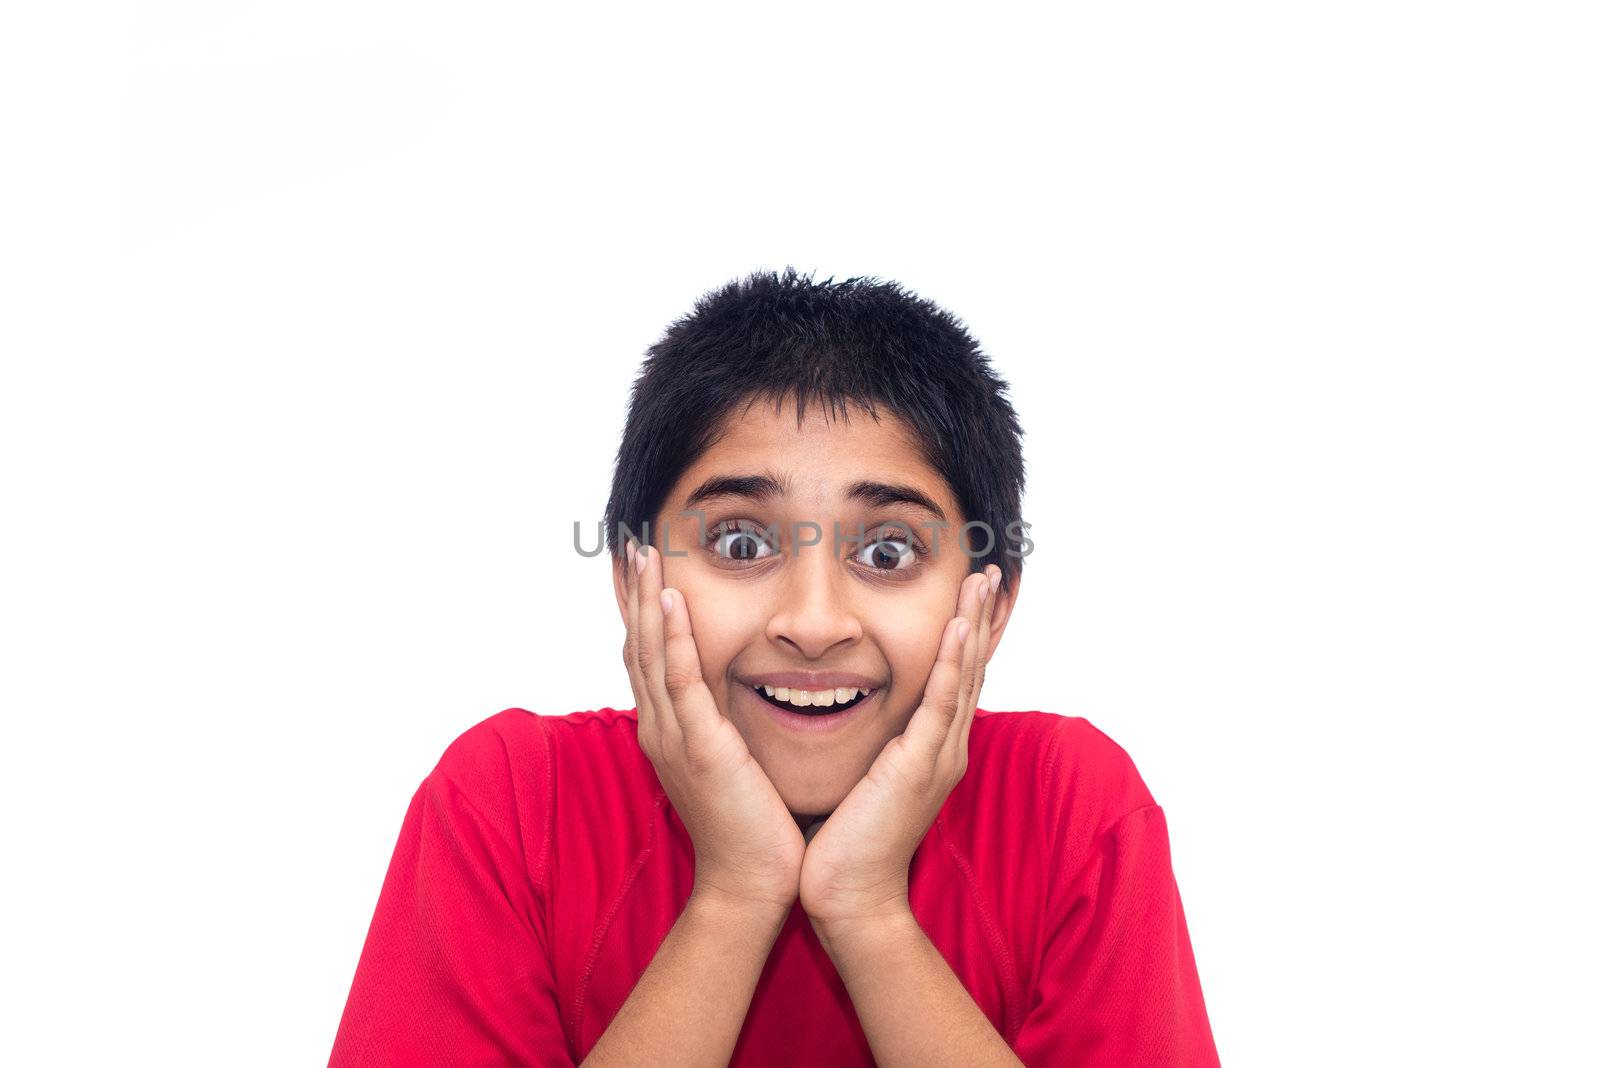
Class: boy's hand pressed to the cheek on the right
800,564,1000,942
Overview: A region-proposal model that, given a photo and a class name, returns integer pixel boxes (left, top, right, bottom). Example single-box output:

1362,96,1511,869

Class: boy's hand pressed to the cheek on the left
622,540,805,911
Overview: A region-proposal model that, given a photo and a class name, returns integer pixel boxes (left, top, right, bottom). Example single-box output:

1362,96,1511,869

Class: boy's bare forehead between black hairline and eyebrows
672,400,957,516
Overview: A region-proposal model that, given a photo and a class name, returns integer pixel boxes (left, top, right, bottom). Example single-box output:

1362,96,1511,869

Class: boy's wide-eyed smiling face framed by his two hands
614,400,1018,817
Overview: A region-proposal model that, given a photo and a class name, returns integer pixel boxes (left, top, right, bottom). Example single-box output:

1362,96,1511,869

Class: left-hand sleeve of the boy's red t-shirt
328,716,576,1068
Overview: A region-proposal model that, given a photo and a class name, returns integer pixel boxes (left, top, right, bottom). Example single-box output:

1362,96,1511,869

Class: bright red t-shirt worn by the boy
330,708,1218,1068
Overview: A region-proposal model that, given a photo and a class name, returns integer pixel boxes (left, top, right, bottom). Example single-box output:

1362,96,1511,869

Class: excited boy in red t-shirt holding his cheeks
331,269,1216,1066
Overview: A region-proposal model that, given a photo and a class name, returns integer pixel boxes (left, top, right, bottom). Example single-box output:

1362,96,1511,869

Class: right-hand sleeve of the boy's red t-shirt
1013,804,1218,1068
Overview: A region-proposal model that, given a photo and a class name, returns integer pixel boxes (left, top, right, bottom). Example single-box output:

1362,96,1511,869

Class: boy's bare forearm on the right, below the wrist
814,910,1022,1068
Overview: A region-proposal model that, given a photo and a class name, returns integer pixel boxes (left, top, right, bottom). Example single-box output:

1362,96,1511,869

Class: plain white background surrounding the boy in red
0,0,1600,1068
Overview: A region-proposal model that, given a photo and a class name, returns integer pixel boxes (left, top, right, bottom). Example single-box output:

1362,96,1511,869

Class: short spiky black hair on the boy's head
605,267,1032,588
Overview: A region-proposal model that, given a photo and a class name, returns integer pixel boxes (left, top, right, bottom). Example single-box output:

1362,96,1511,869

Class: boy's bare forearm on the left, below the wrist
582,895,787,1068
